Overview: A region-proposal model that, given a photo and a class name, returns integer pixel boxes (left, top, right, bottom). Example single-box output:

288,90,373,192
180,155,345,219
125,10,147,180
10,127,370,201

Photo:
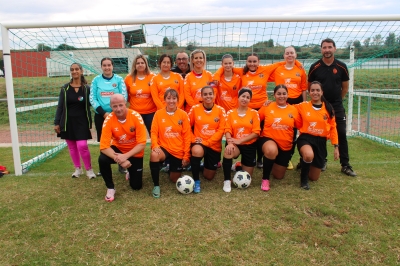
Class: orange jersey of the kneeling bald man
100,109,147,157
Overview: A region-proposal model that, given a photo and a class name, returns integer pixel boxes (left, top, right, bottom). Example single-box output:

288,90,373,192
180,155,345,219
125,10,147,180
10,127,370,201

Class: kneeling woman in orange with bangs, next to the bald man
150,89,191,198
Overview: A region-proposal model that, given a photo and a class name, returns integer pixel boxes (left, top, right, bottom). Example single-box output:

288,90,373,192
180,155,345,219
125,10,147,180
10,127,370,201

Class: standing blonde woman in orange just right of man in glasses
184,50,213,113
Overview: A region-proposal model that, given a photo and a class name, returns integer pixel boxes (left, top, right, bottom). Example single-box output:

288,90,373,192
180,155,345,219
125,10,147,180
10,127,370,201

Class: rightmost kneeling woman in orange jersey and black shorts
295,81,339,190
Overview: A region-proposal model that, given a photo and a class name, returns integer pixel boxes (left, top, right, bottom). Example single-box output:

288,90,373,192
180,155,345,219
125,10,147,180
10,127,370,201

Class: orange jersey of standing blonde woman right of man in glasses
184,70,215,112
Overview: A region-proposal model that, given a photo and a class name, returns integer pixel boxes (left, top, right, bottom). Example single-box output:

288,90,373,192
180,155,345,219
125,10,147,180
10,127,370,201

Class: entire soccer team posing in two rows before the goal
54,39,356,202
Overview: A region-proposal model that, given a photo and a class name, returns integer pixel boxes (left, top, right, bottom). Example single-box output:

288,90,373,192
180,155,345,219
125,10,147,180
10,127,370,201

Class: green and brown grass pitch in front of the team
0,138,400,265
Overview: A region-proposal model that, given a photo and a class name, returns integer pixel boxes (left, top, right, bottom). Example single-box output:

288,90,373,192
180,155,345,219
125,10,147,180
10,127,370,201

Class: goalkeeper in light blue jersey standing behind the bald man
90,57,128,175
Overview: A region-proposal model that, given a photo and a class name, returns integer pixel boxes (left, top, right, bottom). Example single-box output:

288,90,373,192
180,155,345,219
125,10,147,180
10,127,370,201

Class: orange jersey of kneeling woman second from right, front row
258,102,301,151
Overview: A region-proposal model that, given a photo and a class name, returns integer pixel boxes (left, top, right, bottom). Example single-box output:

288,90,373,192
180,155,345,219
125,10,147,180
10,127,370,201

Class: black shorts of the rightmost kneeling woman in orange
297,133,328,169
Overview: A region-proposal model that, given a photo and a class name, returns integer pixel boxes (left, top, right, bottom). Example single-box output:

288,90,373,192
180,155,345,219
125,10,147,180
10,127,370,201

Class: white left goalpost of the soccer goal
1,25,22,176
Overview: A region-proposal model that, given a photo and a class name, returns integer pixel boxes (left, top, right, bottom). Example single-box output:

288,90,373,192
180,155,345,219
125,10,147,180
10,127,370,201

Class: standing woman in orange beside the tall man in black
271,46,307,170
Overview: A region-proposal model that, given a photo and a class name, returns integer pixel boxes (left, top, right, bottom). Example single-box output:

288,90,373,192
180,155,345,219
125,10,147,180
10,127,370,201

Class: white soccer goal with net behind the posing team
0,17,400,175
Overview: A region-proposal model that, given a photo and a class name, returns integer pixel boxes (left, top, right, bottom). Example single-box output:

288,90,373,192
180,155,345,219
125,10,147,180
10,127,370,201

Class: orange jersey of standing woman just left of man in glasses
150,71,185,110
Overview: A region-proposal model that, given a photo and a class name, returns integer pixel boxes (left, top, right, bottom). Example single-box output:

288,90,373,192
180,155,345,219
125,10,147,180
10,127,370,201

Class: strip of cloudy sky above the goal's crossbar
0,0,400,49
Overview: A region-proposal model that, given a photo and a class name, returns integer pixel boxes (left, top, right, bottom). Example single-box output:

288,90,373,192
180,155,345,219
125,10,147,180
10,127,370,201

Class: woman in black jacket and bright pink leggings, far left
54,63,96,179
